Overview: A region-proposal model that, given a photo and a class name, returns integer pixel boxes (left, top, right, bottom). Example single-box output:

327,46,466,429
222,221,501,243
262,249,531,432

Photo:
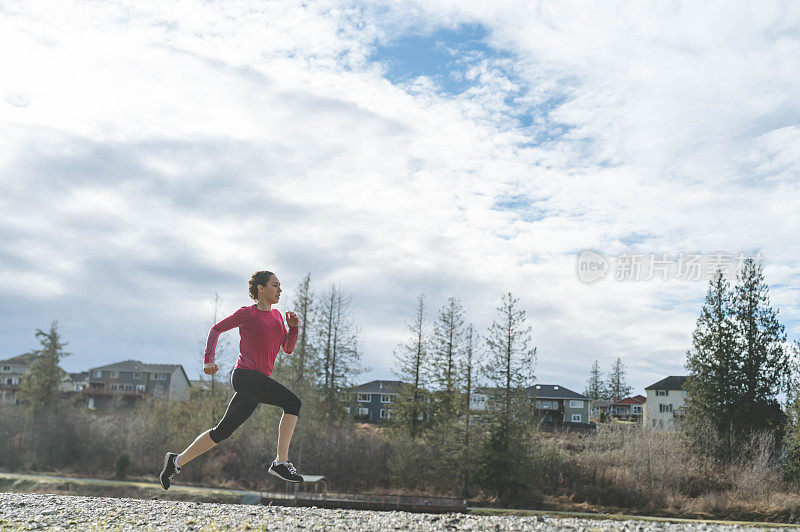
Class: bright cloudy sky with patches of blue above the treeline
0,0,800,393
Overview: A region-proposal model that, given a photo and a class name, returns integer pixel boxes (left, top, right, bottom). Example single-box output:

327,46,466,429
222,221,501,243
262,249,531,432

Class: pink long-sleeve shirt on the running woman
205,305,298,377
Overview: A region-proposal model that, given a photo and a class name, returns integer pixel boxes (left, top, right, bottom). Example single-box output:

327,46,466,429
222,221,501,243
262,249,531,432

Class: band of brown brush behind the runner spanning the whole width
0,397,800,522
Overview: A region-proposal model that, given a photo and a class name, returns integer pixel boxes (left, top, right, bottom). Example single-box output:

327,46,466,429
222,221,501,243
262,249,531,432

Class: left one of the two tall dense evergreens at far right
684,270,744,461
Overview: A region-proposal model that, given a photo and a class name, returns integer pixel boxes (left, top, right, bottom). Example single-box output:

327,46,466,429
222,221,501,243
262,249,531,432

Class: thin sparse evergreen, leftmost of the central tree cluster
393,294,428,438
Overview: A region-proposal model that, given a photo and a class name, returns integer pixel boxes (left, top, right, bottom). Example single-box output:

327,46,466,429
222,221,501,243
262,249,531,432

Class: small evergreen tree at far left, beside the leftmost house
20,321,72,414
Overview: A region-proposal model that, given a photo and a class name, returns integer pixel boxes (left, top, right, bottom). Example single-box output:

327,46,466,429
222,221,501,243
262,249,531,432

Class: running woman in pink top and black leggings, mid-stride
160,271,303,490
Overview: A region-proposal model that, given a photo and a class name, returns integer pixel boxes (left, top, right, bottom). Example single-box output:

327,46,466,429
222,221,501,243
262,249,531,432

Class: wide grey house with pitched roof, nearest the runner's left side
83,360,191,408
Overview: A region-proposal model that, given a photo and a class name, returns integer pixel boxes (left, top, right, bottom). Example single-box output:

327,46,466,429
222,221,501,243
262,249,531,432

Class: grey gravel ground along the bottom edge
0,493,800,532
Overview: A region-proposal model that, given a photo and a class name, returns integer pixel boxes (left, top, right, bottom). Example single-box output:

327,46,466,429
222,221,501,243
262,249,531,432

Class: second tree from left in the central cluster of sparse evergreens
428,297,464,420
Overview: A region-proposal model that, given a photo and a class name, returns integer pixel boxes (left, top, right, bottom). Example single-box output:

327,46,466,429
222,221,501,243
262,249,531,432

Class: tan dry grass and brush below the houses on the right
533,426,800,522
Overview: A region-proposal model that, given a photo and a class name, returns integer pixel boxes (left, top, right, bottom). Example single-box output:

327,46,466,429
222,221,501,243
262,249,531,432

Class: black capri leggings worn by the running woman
209,368,300,443
